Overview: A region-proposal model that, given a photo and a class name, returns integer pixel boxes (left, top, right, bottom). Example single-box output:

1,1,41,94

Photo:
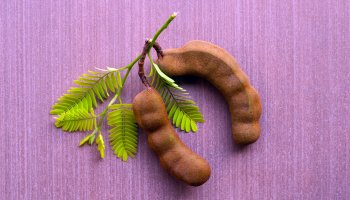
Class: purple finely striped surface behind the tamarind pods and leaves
0,0,350,199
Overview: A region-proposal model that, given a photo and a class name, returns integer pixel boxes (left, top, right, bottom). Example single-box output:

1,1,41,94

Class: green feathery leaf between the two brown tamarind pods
150,63,204,133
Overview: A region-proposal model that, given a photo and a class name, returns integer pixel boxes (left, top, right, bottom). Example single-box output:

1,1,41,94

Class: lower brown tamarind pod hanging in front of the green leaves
133,88,211,186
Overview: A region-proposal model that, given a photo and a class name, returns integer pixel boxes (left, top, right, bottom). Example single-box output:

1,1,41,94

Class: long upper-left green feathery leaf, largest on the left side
50,68,121,115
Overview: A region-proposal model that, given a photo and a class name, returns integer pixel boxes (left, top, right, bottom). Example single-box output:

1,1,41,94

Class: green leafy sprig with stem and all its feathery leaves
50,13,203,161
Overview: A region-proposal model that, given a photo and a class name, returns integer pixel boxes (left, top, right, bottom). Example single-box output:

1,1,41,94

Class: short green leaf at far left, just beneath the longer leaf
55,107,97,132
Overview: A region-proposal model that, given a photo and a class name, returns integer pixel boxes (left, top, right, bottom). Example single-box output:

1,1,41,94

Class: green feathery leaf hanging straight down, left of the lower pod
107,104,138,161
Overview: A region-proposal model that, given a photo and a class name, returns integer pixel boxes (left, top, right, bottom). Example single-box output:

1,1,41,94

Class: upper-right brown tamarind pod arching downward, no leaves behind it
156,40,262,144
